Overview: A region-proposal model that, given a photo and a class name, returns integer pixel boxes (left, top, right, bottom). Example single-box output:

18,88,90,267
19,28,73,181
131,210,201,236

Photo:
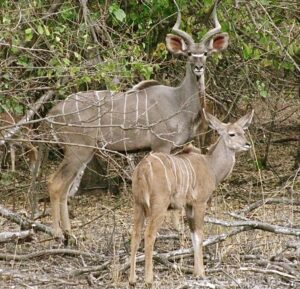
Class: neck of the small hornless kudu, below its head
206,137,235,185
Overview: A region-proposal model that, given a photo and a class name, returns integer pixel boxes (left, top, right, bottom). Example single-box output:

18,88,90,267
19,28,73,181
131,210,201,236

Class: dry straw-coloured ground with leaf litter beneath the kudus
0,132,300,289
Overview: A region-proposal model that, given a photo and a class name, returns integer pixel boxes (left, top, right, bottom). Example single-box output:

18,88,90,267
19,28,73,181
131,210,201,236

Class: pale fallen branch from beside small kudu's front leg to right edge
205,213,300,236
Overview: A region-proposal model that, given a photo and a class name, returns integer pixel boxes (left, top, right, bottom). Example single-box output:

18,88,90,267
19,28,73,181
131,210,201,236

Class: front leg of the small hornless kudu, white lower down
187,203,206,278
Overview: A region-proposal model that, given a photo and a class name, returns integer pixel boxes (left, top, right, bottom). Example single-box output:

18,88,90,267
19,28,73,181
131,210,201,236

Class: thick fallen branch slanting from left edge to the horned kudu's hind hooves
0,205,53,237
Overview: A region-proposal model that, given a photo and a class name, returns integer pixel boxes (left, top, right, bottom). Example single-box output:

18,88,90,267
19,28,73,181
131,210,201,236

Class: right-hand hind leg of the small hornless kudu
145,208,167,284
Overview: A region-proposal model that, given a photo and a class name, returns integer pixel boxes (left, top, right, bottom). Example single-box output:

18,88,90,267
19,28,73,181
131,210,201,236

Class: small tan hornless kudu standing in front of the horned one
129,111,253,284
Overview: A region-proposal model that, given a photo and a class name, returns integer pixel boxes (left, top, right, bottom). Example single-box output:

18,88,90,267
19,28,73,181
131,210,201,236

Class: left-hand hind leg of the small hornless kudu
129,204,145,285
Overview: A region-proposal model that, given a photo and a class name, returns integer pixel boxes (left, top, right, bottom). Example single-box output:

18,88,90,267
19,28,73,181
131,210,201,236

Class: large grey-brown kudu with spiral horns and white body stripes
48,2,228,237
